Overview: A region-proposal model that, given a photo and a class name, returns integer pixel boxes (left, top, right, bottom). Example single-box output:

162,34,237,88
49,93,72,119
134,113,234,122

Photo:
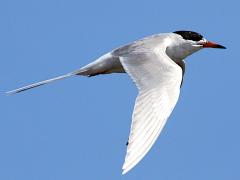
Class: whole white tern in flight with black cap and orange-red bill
7,31,225,174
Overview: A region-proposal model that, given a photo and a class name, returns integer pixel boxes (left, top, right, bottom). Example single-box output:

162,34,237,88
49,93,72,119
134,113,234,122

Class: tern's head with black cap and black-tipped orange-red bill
167,31,226,61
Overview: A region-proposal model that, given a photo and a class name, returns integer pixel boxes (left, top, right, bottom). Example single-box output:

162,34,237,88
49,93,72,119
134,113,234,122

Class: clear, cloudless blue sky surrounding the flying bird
0,0,240,180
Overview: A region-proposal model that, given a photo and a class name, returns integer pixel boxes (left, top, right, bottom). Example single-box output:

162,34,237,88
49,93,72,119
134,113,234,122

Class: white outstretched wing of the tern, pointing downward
120,50,182,174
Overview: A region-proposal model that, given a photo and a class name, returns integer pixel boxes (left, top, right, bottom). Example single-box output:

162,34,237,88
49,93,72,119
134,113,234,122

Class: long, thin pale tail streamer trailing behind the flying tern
6,73,75,95
